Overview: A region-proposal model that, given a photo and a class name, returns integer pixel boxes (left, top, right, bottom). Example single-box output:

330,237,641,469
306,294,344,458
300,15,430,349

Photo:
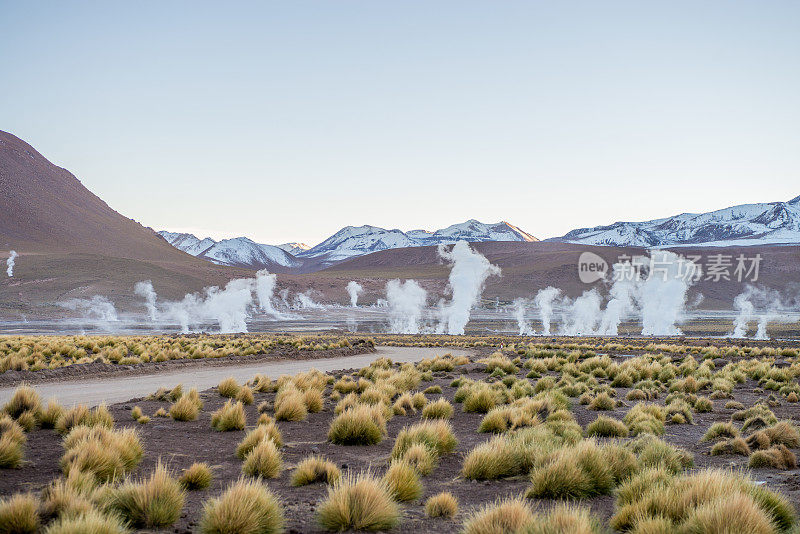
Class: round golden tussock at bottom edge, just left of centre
317,473,400,532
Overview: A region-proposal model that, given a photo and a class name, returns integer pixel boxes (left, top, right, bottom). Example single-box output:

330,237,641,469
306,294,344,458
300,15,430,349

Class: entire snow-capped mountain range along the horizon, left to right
159,196,800,272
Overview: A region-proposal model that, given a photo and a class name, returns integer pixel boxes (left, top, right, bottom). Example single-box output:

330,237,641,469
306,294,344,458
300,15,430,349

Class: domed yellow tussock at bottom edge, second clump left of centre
200,479,286,534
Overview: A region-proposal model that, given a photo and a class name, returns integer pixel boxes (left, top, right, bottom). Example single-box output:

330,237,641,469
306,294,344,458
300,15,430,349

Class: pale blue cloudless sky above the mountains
0,0,800,245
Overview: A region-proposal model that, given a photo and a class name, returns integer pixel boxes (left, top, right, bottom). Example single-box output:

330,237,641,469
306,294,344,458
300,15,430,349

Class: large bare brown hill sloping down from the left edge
0,131,252,316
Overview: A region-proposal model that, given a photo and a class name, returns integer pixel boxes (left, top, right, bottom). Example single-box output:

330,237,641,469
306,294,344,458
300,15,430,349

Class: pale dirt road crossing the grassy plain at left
0,347,467,406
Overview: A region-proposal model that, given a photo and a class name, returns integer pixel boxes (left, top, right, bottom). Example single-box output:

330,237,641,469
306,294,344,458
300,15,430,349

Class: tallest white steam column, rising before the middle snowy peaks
438,241,500,335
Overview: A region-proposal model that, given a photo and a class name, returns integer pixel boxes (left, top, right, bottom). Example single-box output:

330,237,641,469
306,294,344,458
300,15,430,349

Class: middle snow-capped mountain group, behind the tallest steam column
298,219,538,264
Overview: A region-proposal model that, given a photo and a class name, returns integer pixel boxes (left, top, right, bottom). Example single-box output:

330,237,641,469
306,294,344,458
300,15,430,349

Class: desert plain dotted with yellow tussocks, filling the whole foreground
0,334,800,534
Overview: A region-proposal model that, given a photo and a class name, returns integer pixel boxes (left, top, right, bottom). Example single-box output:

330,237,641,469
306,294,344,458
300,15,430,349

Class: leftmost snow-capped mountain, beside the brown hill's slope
158,230,301,269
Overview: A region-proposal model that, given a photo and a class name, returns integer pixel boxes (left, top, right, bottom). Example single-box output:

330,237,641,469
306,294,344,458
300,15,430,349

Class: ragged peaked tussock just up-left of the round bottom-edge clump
100,461,185,528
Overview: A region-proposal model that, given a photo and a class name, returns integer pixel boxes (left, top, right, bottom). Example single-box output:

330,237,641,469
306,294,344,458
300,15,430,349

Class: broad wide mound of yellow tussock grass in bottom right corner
610,469,797,534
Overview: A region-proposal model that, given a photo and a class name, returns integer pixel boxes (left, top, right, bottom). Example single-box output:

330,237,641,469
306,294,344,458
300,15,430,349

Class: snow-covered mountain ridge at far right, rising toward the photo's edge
554,196,800,247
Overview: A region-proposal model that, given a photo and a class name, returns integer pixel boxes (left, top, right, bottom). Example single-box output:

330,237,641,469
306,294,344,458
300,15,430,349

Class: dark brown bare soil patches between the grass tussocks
0,351,800,533
